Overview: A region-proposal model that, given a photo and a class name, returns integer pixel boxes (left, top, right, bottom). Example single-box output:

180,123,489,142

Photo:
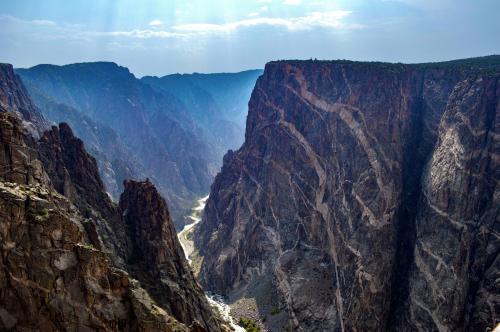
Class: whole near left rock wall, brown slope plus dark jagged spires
0,63,221,331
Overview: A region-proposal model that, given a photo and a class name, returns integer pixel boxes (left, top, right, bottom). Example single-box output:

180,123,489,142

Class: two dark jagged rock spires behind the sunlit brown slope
39,123,223,331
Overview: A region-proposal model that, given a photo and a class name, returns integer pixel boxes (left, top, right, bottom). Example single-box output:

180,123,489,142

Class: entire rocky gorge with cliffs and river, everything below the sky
0,56,500,332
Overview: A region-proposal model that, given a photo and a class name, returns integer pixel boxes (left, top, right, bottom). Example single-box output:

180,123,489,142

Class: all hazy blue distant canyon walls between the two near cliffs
16,62,261,230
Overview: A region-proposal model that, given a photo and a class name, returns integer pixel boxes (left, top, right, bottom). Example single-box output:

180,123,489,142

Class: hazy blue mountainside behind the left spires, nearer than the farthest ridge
17,62,227,227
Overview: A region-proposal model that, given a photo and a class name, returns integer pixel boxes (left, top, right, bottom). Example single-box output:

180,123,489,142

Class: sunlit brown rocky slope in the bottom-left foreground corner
0,182,189,331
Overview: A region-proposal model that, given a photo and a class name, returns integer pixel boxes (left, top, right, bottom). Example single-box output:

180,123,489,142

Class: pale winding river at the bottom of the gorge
177,195,246,332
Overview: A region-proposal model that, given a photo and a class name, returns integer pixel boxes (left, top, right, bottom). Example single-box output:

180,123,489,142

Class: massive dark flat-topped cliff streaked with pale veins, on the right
195,57,500,331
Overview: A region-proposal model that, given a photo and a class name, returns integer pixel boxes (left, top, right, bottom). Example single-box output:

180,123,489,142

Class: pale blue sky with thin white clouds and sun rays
0,0,500,77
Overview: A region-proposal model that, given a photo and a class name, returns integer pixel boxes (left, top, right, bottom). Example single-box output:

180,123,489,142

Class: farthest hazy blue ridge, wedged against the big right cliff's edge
141,69,262,161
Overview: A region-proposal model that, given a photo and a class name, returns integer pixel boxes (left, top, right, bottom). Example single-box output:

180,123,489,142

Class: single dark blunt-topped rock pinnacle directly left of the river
120,181,220,331
